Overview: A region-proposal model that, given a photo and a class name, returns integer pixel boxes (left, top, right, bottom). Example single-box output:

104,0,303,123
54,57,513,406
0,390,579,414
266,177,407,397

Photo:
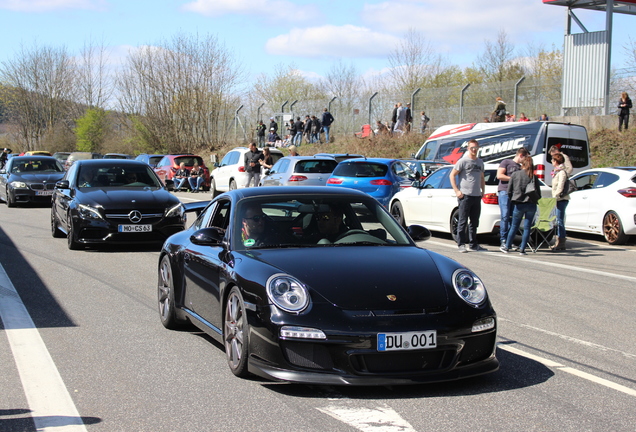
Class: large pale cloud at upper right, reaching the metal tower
361,0,565,49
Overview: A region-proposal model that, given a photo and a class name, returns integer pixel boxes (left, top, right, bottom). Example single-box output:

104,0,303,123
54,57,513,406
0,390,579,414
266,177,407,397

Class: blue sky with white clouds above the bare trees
0,0,636,82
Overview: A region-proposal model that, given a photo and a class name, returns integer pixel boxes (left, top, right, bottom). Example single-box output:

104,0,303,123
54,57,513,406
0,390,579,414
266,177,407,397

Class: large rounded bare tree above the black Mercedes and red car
118,34,242,153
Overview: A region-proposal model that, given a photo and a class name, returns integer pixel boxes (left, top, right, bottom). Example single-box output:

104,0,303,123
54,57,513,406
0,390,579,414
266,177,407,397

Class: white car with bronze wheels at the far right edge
565,167,636,245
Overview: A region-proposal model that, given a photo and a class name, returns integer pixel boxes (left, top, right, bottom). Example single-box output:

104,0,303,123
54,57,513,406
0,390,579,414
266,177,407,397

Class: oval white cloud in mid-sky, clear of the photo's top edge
265,24,400,58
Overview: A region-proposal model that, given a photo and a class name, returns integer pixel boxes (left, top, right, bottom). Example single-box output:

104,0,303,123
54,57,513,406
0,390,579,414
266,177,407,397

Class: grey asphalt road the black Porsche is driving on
0,194,636,432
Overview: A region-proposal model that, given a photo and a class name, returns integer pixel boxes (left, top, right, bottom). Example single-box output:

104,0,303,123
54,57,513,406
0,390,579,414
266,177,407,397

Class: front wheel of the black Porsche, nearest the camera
223,287,249,377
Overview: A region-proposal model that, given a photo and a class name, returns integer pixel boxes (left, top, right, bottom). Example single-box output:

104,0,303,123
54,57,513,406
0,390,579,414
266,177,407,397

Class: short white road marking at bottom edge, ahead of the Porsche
318,406,416,432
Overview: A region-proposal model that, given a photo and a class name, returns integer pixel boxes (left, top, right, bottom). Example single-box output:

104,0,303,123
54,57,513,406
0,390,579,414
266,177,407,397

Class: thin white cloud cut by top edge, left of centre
183,0,321,22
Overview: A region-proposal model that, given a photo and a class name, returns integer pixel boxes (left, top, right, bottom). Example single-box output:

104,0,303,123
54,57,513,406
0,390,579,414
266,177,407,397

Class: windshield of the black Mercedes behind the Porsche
77,164,162,188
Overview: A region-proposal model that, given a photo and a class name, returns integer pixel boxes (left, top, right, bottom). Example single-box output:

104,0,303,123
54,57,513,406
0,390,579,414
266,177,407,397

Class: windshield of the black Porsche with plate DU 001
232,196,412,250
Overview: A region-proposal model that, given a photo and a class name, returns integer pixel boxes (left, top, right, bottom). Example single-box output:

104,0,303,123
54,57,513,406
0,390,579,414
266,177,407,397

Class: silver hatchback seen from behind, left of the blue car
260,156,338,186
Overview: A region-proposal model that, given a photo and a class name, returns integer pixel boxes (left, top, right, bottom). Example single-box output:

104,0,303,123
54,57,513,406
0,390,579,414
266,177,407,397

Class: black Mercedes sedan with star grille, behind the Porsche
51,159,185,249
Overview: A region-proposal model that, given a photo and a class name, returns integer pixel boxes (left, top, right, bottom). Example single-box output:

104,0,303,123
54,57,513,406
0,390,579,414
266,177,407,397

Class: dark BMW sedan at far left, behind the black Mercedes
0,156,64,207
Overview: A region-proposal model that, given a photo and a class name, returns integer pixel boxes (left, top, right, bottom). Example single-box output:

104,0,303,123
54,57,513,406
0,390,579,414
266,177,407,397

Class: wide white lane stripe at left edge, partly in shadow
0,264,86,432
